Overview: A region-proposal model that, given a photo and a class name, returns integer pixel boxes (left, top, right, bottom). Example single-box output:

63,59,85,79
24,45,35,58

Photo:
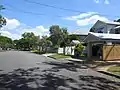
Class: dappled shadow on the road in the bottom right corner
79,75,120,90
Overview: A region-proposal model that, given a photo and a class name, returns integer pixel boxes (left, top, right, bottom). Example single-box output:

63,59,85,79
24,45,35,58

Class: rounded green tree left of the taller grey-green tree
14,32,40,50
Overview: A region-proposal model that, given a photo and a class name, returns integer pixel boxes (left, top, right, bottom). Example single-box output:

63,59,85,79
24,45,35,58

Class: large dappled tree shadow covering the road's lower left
0,67,76,90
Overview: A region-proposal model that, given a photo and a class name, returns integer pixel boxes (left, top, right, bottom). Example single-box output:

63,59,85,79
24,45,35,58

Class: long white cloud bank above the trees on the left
0,18,49,39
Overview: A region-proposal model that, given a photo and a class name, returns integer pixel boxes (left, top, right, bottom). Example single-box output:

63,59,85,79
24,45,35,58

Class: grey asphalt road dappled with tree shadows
0,51,120,90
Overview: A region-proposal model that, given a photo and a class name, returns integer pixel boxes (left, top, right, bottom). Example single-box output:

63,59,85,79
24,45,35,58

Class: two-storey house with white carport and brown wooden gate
84,20,120,60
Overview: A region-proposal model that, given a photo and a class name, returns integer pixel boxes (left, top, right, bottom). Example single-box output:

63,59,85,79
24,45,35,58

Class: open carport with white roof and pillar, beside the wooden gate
84,32,120,59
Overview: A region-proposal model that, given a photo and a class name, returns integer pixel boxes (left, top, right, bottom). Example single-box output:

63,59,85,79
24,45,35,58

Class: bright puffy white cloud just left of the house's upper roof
76,15,109,26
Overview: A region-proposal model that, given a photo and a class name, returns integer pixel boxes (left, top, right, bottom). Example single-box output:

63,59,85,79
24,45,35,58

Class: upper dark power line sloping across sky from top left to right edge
24,0,120,17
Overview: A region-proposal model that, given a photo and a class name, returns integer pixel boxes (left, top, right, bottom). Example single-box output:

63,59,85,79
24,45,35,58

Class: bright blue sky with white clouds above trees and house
0,0,120,39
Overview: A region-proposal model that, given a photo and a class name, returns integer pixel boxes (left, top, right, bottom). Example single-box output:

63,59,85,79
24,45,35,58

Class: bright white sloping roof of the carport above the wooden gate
84,32,120,42
